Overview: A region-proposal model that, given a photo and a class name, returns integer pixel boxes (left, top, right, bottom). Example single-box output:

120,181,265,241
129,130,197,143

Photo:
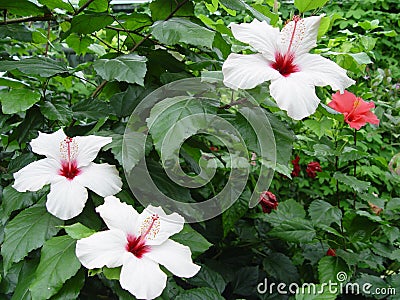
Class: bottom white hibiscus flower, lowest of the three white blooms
76,196,200,299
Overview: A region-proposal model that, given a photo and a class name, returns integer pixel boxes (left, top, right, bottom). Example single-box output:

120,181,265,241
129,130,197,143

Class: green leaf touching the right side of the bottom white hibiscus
171,224,212,257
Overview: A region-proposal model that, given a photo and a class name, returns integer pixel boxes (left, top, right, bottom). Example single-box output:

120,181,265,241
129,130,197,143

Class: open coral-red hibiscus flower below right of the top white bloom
328,91,379,130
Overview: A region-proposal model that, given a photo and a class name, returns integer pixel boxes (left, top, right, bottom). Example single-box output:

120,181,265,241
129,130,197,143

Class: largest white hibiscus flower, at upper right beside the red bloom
222,16,355,120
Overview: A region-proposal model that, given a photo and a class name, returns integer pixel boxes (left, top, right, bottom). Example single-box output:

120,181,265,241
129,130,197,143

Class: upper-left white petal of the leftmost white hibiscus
30,129,66,161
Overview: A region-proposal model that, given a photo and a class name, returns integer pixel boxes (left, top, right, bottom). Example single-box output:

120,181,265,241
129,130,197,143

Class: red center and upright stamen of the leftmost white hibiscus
58,137,81,180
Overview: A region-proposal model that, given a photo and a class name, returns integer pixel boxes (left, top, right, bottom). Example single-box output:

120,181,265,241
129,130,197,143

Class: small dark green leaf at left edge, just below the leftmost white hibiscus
1,186,34,223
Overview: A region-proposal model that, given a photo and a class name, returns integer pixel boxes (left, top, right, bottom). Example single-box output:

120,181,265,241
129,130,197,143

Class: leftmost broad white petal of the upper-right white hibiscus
222,53,281,90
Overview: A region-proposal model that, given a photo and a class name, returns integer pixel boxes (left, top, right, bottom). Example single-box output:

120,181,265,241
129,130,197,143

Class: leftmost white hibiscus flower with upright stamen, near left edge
13,129,122,220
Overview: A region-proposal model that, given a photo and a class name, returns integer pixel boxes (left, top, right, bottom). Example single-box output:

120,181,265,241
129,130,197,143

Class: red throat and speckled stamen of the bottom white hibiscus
125,214,160,258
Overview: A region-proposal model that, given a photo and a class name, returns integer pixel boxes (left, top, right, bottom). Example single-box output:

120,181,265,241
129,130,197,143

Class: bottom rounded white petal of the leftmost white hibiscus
46,176,88,220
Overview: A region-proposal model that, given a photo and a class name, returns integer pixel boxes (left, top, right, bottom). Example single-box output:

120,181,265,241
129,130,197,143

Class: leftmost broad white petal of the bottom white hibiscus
75,230,126,269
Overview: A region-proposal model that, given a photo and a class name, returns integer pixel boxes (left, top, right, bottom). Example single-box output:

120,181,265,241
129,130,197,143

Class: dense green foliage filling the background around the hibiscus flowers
0,0,400,300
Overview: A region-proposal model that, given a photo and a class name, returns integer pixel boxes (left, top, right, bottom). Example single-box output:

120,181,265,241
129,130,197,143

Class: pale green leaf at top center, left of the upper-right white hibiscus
151,18,215,49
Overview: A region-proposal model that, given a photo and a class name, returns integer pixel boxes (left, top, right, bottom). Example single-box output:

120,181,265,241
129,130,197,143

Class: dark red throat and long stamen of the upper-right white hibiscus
271,16,300,77
